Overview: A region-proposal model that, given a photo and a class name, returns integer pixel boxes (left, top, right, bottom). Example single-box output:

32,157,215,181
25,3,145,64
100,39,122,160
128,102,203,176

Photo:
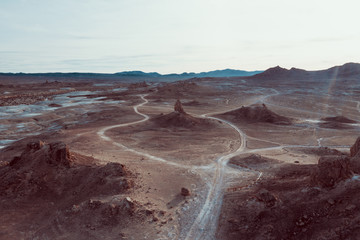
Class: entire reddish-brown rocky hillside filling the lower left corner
0,141,159,239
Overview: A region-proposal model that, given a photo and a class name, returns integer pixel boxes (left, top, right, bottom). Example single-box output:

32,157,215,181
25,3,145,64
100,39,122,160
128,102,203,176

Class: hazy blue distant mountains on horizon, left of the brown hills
0,69,262,81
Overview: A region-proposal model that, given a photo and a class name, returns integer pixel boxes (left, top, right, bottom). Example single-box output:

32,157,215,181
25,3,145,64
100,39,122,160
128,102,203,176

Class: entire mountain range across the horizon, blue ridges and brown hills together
0,63,360,82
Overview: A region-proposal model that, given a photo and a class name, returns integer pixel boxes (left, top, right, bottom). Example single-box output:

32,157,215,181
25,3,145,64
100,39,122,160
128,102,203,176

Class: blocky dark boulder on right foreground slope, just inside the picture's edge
312,156,353,187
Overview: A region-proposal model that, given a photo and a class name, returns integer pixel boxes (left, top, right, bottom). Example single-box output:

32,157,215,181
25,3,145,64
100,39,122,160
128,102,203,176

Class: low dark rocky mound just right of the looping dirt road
220,104,291,125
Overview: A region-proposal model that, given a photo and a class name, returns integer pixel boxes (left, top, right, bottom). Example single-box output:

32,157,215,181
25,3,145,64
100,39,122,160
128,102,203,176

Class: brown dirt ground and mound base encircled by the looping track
108,106,239,164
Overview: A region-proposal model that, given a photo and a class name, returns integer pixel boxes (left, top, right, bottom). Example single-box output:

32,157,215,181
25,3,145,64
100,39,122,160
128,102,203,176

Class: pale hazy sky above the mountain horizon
0,0,360,73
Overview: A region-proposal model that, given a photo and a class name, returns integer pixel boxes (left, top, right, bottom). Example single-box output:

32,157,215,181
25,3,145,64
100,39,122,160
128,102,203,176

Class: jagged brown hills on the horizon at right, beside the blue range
247,63,360,80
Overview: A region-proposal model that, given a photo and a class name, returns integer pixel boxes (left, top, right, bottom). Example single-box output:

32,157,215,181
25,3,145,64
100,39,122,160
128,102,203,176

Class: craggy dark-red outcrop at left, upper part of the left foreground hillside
0,141,132,201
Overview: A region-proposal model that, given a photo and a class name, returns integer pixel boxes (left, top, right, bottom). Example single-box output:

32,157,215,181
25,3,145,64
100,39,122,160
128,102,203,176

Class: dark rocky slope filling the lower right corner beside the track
218,138,360,240
